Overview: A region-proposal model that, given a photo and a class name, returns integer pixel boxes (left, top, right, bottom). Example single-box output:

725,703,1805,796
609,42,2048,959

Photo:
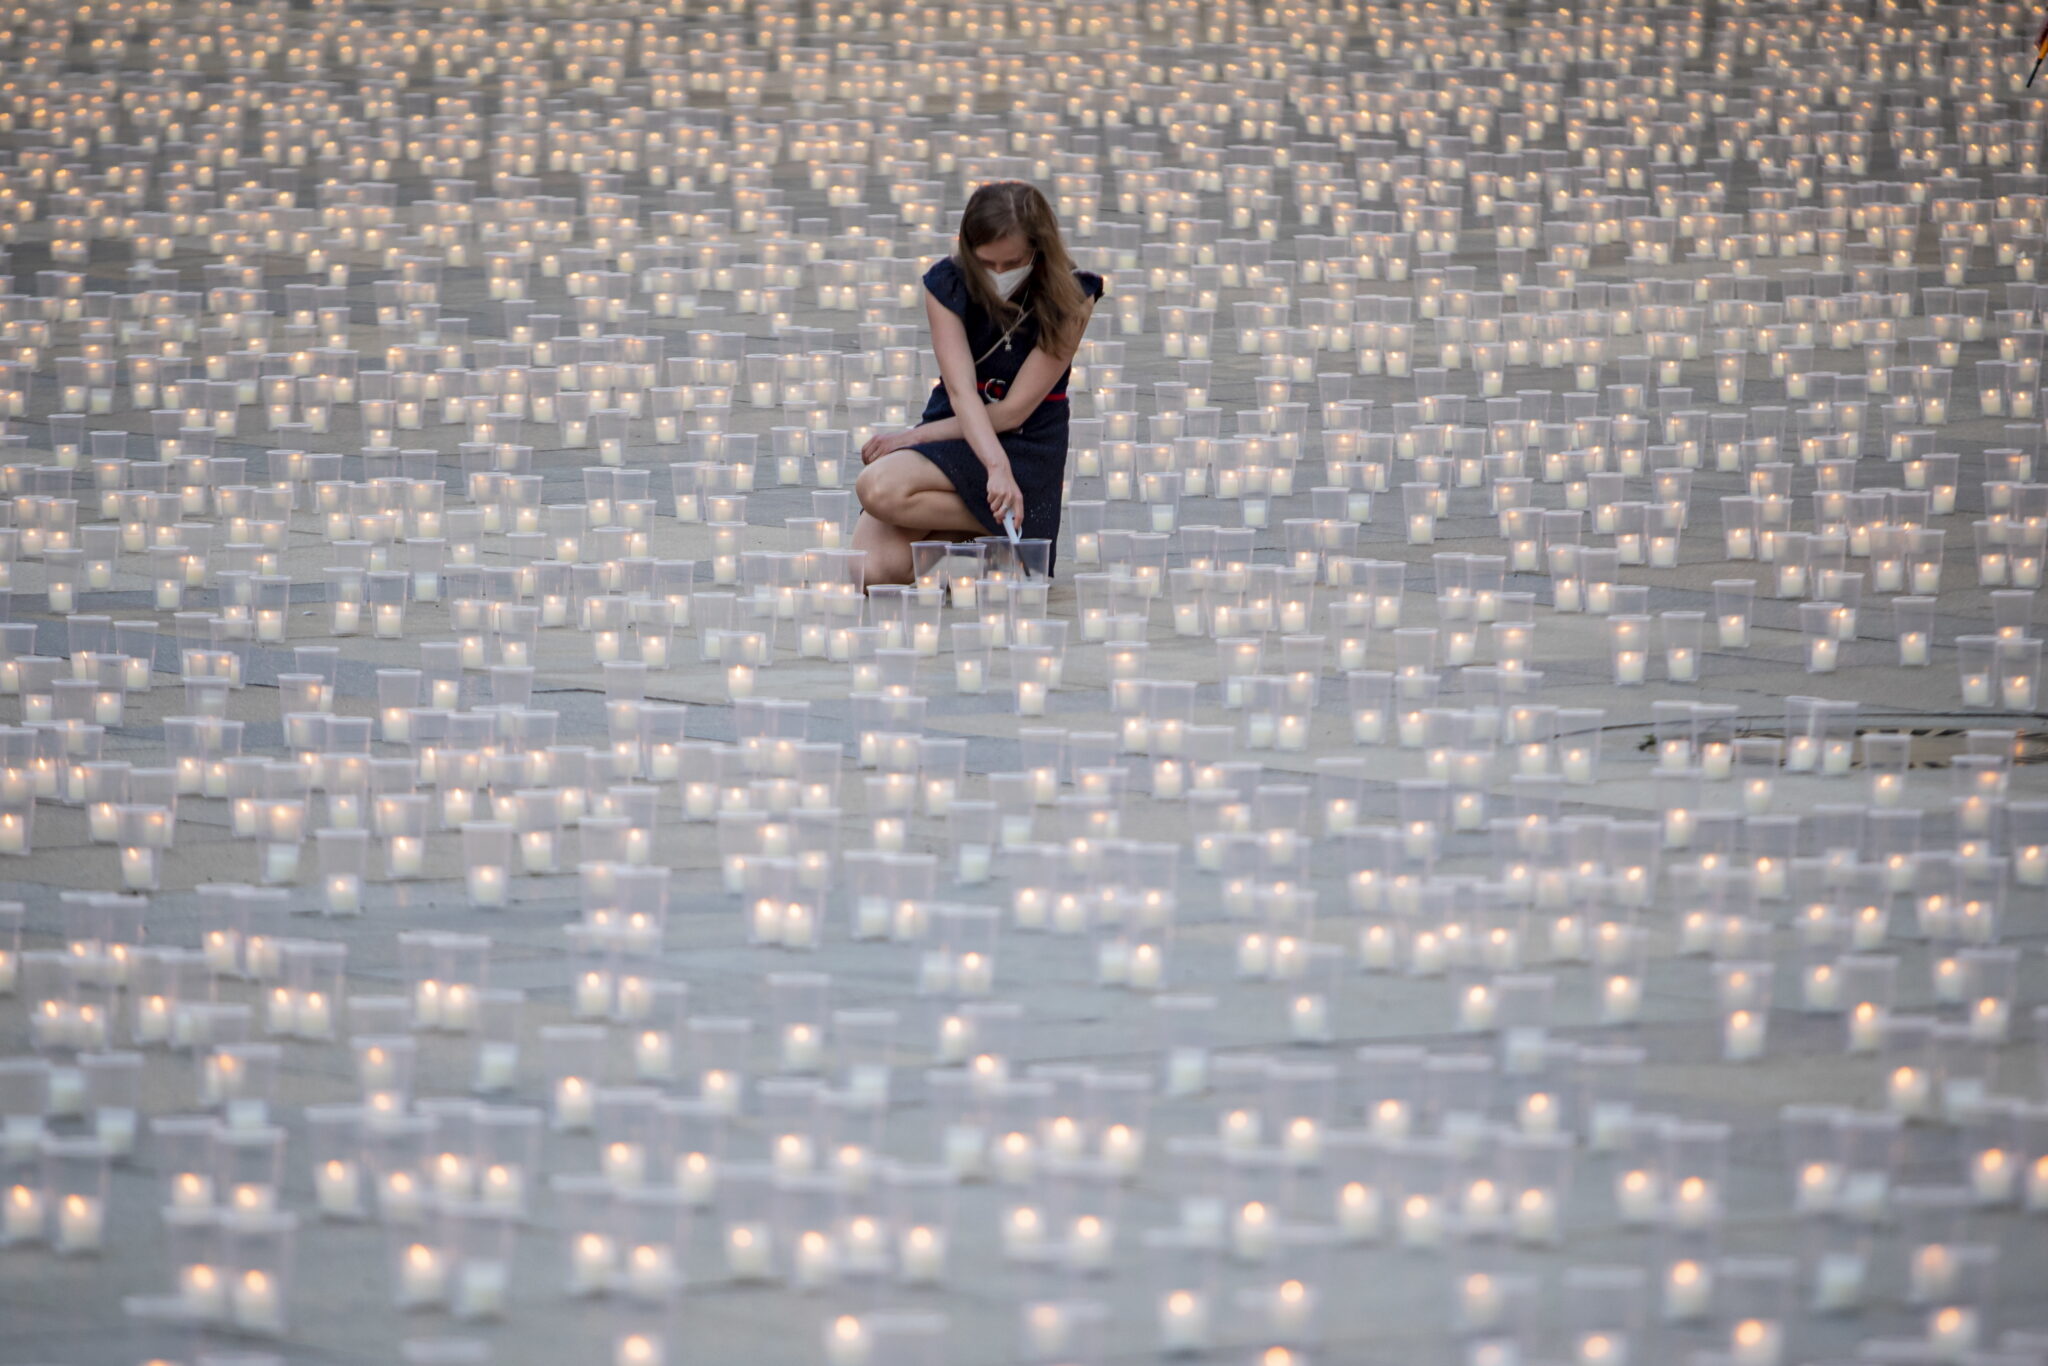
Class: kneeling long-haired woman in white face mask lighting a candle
854,180,1102,584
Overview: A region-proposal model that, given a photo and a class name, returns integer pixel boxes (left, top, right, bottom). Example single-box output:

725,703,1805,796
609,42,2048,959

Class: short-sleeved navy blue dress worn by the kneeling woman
909,256,1102,563
